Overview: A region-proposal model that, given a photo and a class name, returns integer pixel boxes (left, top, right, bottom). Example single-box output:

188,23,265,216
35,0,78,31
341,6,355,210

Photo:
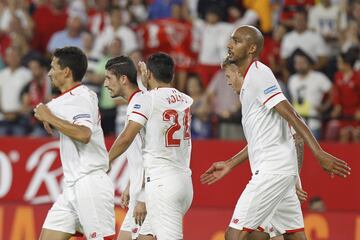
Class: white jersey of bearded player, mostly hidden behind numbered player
125,90,145,202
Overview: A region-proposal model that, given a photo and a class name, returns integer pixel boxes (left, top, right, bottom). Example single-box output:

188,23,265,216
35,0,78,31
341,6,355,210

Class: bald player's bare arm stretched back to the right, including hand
275,101,351,178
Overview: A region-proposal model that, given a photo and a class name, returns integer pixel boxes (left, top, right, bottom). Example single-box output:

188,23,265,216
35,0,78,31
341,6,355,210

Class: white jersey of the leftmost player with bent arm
47,85,109,186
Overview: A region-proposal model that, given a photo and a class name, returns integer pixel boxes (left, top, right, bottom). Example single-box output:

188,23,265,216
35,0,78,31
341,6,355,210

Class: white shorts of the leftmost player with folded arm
43,171,115,239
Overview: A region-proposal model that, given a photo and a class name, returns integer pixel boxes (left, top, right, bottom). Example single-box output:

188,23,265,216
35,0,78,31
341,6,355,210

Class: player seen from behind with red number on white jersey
109,53,193,240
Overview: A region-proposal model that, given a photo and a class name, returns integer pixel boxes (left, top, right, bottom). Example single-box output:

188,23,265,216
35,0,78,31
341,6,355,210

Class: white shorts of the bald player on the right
229,174,304,237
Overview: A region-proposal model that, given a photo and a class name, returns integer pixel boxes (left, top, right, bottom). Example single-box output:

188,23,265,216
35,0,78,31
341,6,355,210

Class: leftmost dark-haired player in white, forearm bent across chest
34,47,115,240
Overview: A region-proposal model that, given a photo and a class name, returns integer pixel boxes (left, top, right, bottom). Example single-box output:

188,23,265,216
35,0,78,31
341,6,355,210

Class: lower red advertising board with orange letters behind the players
0,204,360,240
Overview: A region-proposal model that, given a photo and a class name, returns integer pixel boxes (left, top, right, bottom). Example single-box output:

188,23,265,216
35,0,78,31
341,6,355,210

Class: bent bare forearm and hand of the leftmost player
34,103,91,144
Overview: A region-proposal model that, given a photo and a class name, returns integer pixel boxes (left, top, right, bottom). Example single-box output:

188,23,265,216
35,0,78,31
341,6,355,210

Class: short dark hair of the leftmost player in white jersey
54,47,87,82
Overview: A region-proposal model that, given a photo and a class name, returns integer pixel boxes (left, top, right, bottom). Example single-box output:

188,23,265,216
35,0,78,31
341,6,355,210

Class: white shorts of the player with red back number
145,174,193,240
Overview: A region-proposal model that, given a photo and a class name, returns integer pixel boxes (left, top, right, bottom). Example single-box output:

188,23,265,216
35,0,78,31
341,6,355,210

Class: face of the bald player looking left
228,30,250,62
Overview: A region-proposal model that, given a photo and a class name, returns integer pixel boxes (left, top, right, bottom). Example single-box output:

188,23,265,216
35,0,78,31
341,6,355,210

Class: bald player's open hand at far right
317,151,351,178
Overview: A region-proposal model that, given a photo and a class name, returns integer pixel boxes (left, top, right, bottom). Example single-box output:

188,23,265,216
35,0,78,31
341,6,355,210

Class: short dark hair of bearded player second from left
105,55,138,86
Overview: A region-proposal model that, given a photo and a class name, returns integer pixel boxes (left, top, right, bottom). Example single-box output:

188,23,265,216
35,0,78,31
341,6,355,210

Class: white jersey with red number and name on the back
129,88,193,180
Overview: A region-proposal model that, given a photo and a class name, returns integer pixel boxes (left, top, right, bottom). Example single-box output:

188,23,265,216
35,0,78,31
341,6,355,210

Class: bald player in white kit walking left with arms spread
201,26,351,240
